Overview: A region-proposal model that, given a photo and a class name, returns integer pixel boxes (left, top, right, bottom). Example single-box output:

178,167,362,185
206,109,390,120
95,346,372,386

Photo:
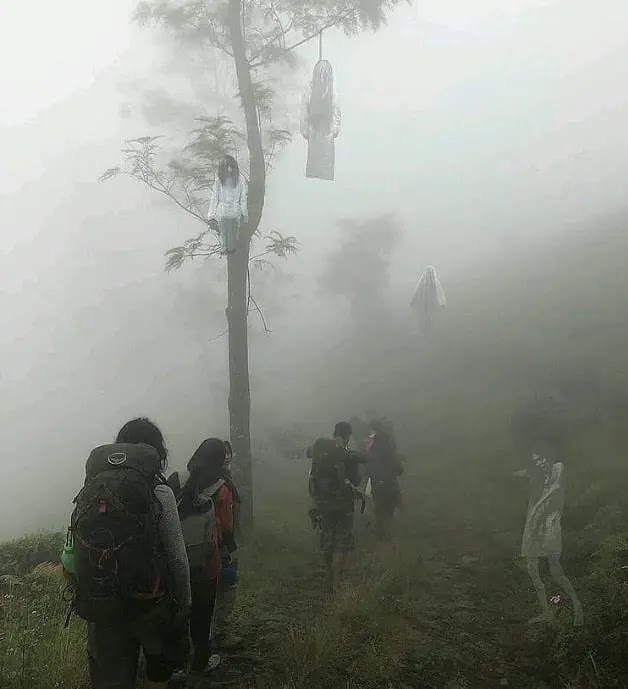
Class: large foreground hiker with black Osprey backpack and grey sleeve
64,418,191,689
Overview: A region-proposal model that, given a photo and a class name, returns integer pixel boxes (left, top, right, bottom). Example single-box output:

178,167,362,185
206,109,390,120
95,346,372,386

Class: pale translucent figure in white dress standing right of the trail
516,454,584,627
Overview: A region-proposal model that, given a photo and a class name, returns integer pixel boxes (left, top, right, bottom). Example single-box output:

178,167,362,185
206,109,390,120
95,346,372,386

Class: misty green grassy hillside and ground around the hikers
0,221,628,689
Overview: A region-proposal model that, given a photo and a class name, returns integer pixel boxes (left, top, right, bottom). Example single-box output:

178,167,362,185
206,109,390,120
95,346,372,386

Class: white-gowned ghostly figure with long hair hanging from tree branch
301,60,341,181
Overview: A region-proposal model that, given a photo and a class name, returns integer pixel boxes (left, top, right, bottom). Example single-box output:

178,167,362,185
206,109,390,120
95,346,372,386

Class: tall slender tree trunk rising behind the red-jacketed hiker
227,0,266,528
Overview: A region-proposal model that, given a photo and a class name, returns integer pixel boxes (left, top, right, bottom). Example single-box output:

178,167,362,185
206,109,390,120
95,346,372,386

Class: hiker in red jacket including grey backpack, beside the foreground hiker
168,438,237,676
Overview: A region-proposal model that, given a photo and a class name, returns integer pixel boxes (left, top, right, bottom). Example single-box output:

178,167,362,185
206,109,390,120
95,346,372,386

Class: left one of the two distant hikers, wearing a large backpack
309,421,364,591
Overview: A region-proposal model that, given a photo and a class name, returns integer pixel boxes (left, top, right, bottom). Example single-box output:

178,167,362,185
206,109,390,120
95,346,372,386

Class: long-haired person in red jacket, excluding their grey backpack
168,438,237,672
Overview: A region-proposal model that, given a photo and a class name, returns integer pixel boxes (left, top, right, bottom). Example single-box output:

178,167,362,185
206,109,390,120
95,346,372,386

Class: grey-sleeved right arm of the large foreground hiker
155,486,192,610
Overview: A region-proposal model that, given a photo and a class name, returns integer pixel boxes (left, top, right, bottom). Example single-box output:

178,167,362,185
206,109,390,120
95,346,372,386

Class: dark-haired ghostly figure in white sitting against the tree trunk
207,155,248,254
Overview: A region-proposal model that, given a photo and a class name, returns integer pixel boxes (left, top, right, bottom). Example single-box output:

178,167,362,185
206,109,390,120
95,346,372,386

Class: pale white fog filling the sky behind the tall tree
0,0,628,537
